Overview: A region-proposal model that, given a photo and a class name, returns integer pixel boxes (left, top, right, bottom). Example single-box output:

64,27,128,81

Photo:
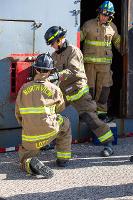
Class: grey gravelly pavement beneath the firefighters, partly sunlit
0,137,133,200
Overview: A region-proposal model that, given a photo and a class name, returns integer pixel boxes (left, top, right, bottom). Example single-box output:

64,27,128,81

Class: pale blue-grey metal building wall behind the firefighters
0,0,80,147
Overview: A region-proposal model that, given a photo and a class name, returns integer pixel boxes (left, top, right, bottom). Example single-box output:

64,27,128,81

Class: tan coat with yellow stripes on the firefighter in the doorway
80,18,121,64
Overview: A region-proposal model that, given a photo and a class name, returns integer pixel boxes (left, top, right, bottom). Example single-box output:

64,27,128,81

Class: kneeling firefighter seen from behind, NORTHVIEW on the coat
15,54,71,178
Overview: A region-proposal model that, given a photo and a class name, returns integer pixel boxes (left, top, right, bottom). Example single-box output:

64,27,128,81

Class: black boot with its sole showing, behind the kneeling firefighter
30,158,54,179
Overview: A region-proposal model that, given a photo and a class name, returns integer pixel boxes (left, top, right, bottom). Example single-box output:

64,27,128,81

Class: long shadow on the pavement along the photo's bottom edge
3,183,133,200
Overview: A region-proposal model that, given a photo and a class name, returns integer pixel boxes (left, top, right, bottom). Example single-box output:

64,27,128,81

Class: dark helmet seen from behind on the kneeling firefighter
33,53,55,71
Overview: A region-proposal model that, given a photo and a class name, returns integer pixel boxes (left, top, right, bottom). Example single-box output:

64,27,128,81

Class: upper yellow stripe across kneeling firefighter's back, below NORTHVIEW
19,105,55,115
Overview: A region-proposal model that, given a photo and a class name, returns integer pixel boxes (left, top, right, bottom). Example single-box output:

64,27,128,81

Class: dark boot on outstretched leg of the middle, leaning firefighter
101,143,114,157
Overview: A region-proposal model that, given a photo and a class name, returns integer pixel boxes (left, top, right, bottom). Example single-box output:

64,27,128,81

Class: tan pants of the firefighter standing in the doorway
84,63,113,112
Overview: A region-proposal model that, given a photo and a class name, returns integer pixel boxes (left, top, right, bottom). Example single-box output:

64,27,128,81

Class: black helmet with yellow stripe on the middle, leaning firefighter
44,26,67,45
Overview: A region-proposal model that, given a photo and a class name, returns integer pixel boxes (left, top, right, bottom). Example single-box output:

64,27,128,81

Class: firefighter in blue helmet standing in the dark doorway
81,1,120,119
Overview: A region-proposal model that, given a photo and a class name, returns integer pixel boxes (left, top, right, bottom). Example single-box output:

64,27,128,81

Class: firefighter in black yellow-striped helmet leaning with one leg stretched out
44,26,113,156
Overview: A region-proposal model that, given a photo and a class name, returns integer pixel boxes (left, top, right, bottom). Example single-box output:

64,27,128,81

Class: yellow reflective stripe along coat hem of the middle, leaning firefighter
66,85,89,101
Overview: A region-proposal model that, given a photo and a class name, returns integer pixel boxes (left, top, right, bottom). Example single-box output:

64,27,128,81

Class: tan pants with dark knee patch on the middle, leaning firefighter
71,93,113,143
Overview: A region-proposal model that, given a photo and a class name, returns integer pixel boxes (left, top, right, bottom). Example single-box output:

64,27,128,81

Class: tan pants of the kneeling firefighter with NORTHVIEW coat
18,116,72,170
